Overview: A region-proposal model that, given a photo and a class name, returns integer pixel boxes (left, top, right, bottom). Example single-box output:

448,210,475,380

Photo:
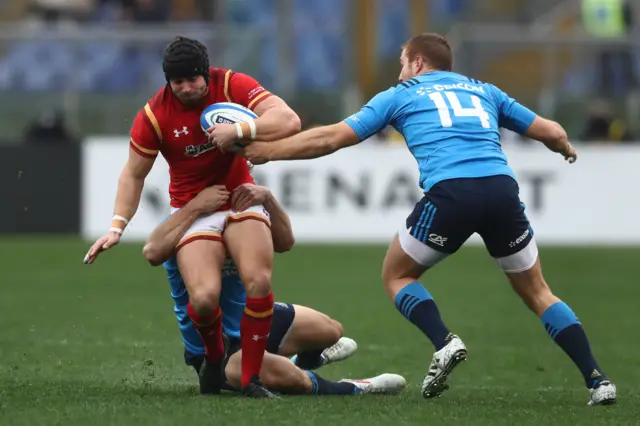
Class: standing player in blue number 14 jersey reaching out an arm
238,34,616,405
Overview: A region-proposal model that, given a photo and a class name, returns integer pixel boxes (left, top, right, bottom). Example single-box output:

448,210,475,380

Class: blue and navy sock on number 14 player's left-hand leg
395,282,449,351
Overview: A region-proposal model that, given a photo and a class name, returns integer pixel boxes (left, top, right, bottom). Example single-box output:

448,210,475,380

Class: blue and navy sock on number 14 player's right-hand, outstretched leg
540,302,605,389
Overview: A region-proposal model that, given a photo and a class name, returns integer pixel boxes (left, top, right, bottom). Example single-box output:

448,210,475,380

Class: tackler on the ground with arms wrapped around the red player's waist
143,184,406,396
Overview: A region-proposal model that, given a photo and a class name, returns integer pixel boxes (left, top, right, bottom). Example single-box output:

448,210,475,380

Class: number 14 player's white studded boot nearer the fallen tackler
422,334,467,398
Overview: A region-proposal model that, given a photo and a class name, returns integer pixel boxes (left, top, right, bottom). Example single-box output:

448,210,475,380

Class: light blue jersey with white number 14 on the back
345,71,536,191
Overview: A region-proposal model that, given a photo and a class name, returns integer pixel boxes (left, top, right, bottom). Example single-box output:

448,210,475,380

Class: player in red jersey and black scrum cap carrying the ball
86,37,300,397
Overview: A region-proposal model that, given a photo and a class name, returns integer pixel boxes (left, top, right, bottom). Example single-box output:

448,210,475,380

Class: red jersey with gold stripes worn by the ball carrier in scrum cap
129,68,271,210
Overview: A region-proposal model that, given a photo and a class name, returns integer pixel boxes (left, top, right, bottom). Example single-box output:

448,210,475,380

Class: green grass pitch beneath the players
0,238,640,426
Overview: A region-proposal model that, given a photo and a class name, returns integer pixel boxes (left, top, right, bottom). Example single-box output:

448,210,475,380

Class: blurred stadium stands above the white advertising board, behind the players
0,0,640,142
